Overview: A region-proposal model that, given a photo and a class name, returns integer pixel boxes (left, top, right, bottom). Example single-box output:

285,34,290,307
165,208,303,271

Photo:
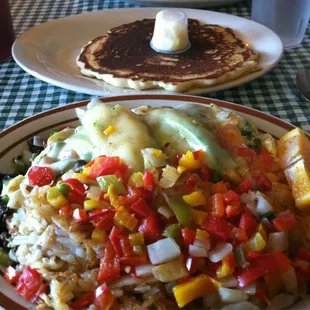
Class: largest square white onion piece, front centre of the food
147,238,181,265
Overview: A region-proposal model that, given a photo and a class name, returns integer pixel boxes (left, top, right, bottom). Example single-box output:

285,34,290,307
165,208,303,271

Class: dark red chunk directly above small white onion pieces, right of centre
202,216,234,241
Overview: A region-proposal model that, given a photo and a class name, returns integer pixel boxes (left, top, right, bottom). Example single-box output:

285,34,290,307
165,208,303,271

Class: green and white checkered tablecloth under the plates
0,0,310,132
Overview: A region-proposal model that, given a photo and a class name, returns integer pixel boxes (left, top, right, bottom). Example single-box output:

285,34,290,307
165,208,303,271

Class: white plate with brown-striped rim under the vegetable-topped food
0,95,310,310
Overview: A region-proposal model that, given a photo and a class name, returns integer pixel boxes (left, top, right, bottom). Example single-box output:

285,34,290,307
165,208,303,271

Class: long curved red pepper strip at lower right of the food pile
238,252,291,287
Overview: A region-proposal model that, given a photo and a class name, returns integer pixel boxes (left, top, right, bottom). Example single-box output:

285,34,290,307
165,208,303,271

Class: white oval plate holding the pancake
12,8,283,96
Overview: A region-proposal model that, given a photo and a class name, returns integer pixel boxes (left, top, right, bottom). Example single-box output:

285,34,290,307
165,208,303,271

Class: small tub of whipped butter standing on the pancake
151,10,190,53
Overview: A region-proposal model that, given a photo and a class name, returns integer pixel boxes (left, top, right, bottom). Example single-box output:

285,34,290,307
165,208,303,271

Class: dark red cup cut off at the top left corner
0,0,15,62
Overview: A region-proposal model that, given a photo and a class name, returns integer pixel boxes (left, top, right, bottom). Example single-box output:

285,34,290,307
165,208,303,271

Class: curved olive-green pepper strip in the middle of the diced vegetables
164,195,192,227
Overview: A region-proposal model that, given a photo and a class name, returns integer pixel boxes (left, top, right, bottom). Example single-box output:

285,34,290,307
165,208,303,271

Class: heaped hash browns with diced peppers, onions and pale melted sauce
0,99,310,310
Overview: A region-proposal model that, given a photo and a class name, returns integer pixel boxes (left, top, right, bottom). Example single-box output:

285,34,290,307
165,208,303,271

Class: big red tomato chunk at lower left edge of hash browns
16,266,42,300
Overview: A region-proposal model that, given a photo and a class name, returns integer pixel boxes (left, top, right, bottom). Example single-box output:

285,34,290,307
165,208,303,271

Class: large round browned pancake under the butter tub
77,19,260,91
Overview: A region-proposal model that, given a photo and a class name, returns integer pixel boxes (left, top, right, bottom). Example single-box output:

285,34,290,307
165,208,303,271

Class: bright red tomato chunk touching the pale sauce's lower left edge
87,156,121,180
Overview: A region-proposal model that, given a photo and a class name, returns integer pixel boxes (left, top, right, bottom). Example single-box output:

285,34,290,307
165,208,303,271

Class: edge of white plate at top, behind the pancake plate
125,0,241,8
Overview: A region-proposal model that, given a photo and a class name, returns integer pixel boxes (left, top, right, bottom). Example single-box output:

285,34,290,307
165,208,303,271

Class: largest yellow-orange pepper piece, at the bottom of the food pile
173,274,221,308
